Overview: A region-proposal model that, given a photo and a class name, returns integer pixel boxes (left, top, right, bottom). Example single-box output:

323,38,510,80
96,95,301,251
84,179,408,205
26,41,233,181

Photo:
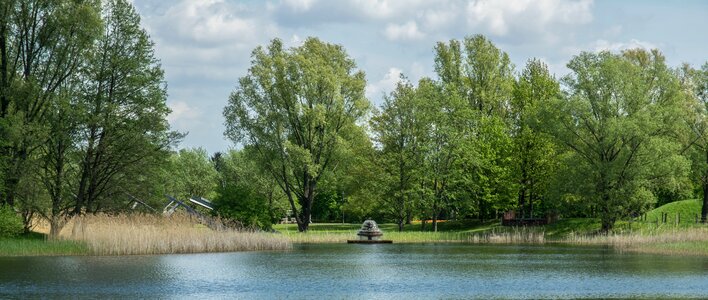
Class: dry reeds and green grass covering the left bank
0,214,291,256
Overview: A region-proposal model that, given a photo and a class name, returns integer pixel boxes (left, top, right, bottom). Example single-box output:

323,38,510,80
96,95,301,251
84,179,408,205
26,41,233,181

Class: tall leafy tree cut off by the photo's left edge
0,0,100,205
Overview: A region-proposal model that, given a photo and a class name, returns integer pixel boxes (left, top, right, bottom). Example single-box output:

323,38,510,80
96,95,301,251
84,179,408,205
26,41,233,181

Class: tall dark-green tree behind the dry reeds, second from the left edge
73,0,180,214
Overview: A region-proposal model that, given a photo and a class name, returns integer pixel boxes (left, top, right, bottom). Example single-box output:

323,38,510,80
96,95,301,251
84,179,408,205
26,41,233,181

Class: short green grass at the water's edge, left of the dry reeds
0,232,89,256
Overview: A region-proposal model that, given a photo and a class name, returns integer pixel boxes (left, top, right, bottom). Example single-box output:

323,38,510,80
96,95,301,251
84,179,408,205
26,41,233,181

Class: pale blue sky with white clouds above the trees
131,0,708,153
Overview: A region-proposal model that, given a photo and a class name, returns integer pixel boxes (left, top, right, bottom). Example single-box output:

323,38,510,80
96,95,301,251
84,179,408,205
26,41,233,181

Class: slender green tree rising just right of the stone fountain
371,78,427,231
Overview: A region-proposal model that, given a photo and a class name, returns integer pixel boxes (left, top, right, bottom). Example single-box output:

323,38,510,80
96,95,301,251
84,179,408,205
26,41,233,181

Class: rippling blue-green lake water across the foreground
0,244,708,299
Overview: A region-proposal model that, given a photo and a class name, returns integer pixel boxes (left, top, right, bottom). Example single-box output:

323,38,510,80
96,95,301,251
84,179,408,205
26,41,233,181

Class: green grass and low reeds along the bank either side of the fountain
275,219,708,256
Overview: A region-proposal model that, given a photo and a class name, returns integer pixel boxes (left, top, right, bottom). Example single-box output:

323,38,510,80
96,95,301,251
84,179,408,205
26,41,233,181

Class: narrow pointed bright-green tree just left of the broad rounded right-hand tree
511,59,560,217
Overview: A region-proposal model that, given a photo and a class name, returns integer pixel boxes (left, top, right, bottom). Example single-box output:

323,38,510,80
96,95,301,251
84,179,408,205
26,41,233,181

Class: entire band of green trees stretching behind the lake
0,0,708,235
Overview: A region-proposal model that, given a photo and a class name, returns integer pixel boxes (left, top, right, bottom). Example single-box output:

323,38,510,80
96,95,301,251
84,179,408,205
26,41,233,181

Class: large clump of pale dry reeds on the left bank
60,214,291,255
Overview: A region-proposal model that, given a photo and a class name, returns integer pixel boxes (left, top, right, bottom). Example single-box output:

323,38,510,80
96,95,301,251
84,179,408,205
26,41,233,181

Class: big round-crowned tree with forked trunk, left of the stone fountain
224,38,369,231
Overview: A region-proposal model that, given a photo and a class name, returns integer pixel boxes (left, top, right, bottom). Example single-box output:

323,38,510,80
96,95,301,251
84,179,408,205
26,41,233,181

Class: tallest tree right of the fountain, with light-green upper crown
435,35,516,220
